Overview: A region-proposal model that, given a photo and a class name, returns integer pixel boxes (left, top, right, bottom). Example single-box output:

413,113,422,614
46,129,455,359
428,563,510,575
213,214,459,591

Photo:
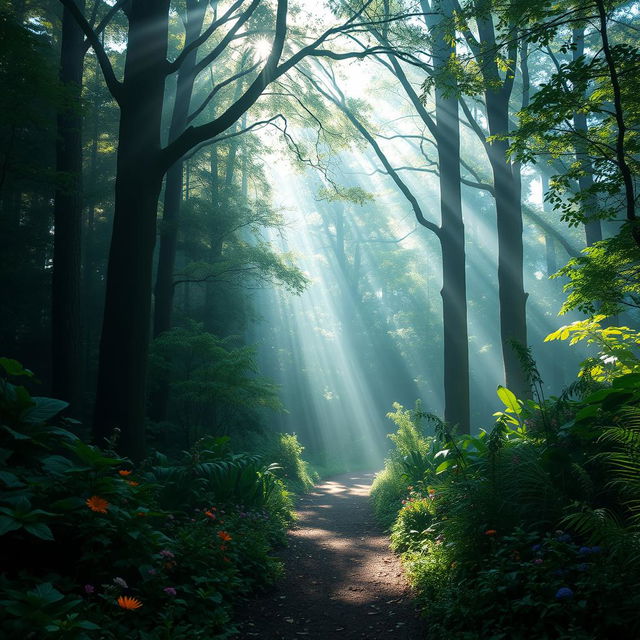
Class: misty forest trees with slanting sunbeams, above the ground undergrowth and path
0,0,637,464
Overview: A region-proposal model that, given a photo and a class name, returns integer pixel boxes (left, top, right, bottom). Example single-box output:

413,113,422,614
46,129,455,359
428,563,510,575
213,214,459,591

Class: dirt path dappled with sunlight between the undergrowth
235,473,423,640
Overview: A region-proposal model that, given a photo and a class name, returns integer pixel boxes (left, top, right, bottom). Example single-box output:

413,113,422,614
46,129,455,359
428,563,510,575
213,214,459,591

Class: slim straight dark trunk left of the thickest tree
51,0,84,416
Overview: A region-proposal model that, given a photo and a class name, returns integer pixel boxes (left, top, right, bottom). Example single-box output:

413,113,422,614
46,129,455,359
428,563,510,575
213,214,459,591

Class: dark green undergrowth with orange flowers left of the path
0,358,302,640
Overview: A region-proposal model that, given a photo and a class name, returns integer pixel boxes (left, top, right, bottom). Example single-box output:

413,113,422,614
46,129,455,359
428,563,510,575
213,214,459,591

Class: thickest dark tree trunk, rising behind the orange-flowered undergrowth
94,0,169,460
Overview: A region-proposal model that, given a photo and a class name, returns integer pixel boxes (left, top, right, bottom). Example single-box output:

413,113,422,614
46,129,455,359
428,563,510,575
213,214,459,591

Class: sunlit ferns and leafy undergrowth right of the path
372,344,640,640
